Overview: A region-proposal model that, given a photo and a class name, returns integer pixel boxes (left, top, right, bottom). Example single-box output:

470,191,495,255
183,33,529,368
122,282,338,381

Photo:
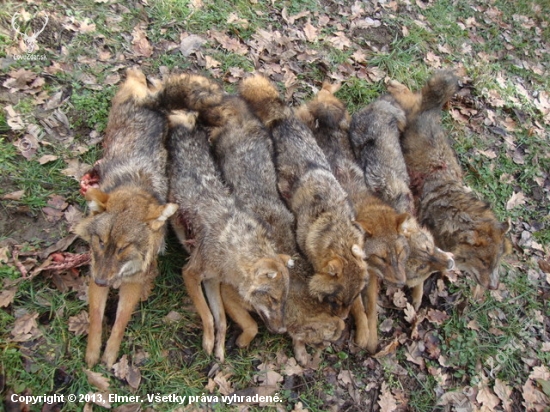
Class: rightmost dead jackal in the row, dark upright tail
388,71,511,289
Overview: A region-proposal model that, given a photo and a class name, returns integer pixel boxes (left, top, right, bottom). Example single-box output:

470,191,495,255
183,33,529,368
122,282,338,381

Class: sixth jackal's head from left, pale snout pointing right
406,225,455,287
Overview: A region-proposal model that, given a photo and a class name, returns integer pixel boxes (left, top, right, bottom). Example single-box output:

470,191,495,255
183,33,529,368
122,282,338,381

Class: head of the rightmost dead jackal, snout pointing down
451,221,512,290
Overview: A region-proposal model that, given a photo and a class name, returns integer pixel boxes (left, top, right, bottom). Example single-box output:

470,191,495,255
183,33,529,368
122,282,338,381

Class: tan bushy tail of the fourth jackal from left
239,75,290,127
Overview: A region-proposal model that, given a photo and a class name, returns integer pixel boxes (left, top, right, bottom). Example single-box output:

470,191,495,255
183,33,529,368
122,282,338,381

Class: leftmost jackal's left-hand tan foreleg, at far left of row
86,279,109,368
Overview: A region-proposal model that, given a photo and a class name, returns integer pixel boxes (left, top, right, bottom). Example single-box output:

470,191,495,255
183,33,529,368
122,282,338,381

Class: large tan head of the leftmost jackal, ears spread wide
75,188,178,287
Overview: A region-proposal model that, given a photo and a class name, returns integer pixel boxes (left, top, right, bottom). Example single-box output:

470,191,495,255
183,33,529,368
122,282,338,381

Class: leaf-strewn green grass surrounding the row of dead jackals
0,0,550,411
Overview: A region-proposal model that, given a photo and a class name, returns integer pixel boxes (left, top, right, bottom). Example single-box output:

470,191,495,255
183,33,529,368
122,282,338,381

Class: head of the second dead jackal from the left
243,254,293,333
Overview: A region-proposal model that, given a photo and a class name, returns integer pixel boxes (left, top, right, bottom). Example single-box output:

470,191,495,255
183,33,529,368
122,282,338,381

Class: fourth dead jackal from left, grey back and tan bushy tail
240,76,368,317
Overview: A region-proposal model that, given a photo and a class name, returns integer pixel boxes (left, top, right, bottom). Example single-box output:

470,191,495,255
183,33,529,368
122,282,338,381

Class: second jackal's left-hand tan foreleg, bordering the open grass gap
182,265,214,355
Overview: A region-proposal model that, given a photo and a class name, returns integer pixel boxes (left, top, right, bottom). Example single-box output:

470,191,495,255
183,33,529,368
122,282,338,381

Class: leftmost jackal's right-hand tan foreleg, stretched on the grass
101,282,143,368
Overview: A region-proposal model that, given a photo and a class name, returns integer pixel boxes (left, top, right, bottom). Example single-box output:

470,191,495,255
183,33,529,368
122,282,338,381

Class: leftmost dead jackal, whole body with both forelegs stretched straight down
75,69,177,367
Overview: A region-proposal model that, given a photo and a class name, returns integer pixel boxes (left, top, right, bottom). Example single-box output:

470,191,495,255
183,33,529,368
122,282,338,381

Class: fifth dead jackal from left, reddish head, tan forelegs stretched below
298,83,413,352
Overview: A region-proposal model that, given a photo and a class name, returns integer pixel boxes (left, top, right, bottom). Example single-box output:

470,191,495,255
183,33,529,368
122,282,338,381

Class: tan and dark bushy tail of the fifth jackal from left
296,82,349,129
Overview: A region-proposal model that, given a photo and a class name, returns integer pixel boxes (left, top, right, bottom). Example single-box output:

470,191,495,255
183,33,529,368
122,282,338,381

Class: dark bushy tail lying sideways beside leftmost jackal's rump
158,73,224,112
